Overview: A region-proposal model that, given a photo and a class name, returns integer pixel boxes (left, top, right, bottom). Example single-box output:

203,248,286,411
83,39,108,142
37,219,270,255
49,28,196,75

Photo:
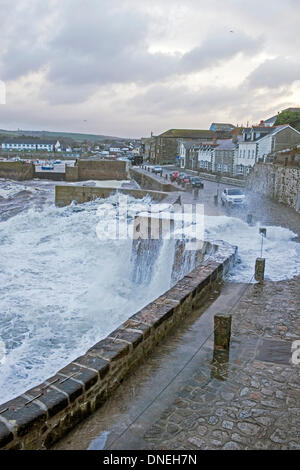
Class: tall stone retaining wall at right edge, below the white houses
246,163,300,211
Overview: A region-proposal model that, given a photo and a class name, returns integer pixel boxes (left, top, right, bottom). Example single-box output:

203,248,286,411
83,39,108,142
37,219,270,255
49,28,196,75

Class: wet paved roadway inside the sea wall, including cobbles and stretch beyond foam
53,174,300,450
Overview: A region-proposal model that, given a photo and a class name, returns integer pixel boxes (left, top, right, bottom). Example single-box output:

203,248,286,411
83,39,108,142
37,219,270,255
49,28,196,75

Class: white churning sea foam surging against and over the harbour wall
0,185,300,403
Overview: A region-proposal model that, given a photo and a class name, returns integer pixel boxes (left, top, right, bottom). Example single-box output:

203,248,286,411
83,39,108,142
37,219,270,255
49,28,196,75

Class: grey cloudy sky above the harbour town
0,0,300,137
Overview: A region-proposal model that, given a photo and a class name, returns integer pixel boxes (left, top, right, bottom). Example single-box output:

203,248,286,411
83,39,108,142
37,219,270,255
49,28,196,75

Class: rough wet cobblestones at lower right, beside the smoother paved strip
144,278,300,450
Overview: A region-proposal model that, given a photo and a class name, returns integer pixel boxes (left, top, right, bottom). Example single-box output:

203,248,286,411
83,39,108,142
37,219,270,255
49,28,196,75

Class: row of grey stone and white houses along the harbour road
141,116,300,177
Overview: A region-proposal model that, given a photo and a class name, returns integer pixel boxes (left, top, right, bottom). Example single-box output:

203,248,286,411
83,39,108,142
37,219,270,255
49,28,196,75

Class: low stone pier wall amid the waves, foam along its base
55,186,172,207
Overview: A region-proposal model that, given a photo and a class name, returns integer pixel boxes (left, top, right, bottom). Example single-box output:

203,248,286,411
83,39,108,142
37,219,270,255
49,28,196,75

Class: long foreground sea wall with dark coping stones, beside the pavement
0,242,237,450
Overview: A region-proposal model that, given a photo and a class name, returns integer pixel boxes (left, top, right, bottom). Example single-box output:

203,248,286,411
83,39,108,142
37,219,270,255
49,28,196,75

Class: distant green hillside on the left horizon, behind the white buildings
0,129,130,142
